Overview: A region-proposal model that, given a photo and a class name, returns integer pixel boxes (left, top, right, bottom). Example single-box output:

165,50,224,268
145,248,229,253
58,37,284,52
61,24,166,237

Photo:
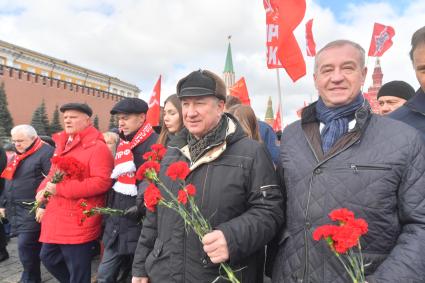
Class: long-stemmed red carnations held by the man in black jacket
136,144,239,283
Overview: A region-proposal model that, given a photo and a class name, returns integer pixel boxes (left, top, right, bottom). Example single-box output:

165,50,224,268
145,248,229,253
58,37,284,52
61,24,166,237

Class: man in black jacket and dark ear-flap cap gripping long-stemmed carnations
132,70,283,283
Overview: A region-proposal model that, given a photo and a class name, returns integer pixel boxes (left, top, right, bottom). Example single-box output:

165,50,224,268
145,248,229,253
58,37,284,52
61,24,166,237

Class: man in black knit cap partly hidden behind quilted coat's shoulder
377,81,415,115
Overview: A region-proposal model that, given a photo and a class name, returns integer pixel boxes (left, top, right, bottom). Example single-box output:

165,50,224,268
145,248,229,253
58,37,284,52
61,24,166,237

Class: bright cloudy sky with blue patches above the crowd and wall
0,0,425,124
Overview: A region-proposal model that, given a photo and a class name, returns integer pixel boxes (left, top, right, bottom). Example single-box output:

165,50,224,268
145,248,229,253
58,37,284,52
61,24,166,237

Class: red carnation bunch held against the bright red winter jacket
25,156,86,214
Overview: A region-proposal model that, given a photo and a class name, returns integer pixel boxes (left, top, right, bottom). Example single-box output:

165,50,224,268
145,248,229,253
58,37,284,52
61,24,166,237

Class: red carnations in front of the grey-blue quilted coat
313,208,368,283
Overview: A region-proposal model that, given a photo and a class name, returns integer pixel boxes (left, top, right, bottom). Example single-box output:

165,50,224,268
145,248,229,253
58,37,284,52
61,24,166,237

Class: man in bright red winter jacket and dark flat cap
36,103,113,283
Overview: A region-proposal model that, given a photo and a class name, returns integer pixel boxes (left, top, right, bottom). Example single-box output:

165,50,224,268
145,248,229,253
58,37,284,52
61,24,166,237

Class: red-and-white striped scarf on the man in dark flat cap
111,123,153,196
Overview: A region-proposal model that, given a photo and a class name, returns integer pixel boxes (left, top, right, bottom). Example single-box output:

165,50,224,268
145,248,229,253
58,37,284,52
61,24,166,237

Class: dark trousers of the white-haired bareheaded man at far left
18,231,41,283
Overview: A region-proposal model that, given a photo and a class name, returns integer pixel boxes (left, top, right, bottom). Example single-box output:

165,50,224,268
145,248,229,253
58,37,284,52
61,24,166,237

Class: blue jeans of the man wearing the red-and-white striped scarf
97,248,133,283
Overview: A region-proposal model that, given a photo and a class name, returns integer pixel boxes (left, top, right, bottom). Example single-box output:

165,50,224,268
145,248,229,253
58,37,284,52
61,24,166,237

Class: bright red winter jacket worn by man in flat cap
38,126,113,244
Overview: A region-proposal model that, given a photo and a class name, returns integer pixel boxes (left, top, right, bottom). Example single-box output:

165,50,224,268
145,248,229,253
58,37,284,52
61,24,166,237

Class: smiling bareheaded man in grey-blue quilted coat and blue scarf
272,40,425,283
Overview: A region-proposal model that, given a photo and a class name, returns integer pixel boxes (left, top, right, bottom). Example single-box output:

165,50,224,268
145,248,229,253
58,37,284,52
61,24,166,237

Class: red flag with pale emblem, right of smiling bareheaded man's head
368,23,395,57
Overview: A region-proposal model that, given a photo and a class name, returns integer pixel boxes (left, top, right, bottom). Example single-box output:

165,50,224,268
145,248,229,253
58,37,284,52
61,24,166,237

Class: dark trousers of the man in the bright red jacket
40,241,95,283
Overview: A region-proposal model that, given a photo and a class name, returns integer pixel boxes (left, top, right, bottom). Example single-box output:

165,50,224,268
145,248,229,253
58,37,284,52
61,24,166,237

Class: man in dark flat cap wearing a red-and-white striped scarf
97,98,158,283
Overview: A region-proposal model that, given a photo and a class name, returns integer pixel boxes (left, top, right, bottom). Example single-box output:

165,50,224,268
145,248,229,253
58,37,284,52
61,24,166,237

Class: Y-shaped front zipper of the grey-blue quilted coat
298,134,359,283
